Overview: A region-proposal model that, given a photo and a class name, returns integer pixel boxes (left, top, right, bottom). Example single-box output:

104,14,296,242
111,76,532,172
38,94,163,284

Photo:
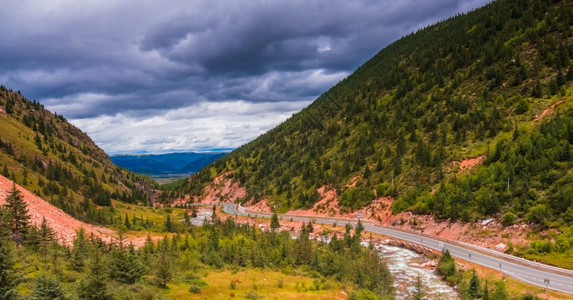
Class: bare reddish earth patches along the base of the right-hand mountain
190,168,531,251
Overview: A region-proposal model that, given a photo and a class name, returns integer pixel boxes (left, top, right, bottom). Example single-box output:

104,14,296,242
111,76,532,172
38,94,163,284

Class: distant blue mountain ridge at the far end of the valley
110,152,225,176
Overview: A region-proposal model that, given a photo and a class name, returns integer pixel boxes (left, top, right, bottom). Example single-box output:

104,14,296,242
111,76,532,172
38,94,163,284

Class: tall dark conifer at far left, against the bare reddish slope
4,184,30,244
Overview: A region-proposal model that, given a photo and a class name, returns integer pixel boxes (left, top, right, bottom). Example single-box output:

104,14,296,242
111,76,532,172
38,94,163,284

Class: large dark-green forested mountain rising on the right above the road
179,0,573,226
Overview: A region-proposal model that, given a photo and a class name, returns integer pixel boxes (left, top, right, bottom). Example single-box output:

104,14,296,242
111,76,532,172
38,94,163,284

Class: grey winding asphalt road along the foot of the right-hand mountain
193,203,573,294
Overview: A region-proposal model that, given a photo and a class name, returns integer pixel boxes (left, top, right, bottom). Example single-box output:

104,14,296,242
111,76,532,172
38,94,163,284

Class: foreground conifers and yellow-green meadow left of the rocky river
0,187,394,300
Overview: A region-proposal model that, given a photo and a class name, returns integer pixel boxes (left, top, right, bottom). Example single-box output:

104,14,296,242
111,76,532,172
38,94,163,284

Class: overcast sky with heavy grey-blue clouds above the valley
0,0,487,154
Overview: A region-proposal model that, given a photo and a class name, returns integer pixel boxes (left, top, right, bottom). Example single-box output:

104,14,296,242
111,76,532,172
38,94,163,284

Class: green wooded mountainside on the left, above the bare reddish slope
0,86,155,224
